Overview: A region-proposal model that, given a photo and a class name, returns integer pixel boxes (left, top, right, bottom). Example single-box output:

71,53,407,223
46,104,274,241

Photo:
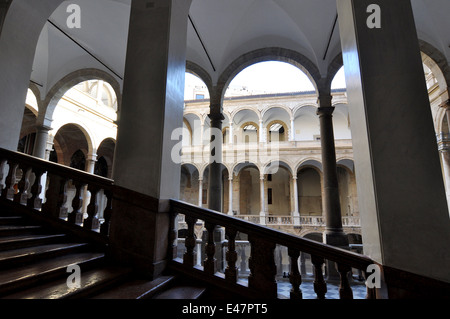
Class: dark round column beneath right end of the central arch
317,95,348,248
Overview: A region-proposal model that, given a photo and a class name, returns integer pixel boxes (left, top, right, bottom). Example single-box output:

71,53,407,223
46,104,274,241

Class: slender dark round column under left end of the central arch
208,111,224,212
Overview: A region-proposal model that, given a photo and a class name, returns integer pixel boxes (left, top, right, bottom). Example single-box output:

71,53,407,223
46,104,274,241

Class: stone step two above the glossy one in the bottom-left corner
0,243,88,269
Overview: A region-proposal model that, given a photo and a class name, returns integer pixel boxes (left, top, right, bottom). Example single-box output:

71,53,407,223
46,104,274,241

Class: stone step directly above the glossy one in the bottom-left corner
0,252,104,296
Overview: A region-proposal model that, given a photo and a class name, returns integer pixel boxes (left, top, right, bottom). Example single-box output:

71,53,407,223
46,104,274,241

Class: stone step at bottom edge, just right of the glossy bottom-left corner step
92,276,174,299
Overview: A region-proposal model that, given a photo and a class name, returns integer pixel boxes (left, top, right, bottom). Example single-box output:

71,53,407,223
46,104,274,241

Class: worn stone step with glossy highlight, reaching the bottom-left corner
2,266,130,299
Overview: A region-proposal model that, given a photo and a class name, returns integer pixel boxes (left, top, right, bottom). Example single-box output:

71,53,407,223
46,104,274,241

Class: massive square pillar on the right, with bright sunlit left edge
337,0,450,290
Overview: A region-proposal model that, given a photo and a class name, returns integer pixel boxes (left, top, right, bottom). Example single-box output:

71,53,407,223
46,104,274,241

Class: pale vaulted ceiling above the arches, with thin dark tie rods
31,0,450,96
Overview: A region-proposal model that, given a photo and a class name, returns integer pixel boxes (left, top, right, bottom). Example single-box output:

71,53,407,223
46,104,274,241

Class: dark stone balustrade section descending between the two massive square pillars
169,200,375,299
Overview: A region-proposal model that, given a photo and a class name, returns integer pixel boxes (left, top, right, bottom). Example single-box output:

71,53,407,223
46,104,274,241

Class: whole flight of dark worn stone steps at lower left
0,208,205,299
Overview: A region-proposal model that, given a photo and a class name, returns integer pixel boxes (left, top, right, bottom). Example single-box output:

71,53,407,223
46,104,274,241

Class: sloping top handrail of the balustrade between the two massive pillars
171,200,374,270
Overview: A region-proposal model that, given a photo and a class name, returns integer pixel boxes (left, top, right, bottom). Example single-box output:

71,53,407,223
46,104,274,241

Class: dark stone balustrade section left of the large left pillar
0,149,113,243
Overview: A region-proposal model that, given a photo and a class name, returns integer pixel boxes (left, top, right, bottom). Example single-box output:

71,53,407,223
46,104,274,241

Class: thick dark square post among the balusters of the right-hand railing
248,237,277,298
